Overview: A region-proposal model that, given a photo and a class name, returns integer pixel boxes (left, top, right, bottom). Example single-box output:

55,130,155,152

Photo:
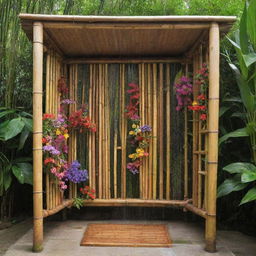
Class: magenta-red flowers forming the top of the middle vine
125,83,140,120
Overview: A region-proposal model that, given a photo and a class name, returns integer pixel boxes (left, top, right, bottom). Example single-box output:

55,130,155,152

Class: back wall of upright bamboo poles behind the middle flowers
74,63,184,200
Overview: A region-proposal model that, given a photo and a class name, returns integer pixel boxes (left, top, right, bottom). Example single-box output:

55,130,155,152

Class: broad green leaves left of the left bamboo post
0,108,32,196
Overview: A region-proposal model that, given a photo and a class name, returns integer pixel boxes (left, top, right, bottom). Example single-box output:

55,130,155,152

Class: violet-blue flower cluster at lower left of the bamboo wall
65,160,88,183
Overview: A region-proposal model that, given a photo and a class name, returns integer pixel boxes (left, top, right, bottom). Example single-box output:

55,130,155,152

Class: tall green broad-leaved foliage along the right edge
218,1,256,205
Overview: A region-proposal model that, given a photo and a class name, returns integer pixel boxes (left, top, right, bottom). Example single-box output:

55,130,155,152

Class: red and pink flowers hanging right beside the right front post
188,64,209,121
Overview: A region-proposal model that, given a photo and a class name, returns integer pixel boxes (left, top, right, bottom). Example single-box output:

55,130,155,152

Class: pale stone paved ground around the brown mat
0,220,256,256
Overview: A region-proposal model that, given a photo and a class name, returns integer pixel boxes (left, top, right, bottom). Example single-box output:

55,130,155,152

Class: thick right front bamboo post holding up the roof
205,23,220,252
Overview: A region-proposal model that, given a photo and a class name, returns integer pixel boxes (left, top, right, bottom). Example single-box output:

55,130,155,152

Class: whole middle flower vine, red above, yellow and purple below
126,83,152,174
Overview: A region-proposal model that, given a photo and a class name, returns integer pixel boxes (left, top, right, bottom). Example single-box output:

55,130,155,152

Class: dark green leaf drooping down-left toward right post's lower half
217,174,248,197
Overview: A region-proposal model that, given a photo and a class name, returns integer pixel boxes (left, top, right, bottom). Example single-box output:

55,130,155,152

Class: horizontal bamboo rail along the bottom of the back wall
84,199,190,207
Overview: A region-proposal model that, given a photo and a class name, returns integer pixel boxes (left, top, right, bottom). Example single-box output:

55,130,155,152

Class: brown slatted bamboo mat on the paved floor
81,224,171,247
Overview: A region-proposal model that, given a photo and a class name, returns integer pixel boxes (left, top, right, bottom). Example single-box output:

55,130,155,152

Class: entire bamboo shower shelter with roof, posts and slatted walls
20,14,235,252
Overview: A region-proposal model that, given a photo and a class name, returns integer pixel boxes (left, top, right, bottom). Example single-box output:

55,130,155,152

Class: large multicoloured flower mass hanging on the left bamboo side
42,77,96,191
